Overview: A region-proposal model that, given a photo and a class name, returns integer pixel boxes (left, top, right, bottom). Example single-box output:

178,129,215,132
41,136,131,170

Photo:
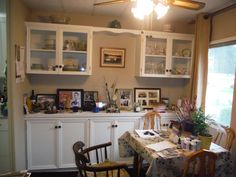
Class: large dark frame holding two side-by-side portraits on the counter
57,89,84,109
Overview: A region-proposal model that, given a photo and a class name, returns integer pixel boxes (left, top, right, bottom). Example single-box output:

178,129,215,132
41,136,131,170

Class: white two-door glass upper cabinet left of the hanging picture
26,23,92,75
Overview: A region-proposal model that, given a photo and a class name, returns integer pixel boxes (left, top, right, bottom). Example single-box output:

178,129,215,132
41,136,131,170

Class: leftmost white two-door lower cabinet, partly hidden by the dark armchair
26,118,88,169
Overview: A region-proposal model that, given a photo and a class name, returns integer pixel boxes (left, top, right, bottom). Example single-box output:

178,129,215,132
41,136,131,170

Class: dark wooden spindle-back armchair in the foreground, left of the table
73,142,129,177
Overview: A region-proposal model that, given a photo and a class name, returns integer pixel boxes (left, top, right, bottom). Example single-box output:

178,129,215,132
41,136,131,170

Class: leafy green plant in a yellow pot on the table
192,108,212,149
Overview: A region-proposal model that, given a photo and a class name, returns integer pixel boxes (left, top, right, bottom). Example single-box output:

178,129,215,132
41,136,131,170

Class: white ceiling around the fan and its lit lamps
24,0,236,21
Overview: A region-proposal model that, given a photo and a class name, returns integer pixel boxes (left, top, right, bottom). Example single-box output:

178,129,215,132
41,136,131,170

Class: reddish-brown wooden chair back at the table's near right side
182,149,217,177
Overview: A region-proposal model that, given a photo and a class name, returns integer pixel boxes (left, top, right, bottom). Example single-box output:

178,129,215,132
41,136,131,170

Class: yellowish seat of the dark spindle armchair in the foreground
87,160,130,177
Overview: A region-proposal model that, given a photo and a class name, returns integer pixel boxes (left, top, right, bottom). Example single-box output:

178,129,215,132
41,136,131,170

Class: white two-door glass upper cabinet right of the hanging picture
137,32,193,78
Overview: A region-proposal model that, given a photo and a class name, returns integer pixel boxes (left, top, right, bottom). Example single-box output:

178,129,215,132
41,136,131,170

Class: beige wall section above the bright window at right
212,8,236,41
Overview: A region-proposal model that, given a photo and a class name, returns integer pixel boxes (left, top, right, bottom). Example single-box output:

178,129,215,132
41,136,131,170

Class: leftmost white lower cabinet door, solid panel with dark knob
27,120,59,169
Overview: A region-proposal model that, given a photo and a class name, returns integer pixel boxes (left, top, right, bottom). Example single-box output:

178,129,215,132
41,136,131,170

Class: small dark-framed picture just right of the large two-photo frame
83,91,98,111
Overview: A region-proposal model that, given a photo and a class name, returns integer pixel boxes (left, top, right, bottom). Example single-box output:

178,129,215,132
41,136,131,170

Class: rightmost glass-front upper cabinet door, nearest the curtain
170,39,193,78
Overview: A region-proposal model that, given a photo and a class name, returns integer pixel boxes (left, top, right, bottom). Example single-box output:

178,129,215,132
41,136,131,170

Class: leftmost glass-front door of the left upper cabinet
27,25,58,74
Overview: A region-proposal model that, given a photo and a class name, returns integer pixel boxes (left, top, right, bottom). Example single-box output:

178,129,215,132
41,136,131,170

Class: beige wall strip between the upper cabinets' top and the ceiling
29,11,194,34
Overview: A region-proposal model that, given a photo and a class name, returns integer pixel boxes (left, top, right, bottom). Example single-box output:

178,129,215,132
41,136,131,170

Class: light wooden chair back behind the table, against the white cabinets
143,111,161,130
